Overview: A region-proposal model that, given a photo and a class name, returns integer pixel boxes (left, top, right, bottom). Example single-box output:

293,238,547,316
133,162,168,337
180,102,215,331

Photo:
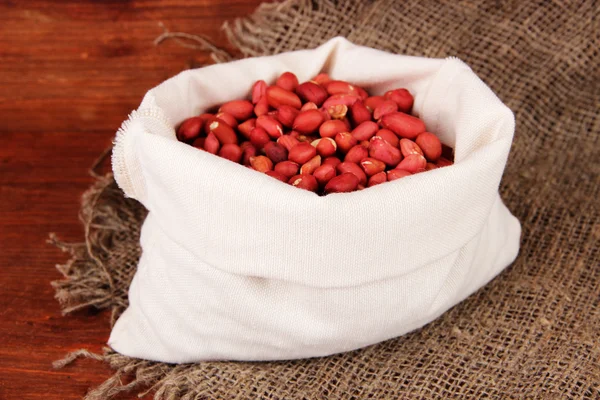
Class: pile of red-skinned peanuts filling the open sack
177,72,453,195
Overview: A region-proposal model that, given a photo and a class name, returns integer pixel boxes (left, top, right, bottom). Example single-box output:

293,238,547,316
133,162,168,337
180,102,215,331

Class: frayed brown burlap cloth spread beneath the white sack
54,0,600,399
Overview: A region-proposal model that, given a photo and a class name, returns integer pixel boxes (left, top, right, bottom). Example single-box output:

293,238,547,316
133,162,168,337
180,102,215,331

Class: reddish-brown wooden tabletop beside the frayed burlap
0,0,260,399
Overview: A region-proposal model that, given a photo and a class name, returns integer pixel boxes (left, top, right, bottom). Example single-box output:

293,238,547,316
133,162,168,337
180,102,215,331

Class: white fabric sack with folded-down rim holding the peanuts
108,38,521,363
